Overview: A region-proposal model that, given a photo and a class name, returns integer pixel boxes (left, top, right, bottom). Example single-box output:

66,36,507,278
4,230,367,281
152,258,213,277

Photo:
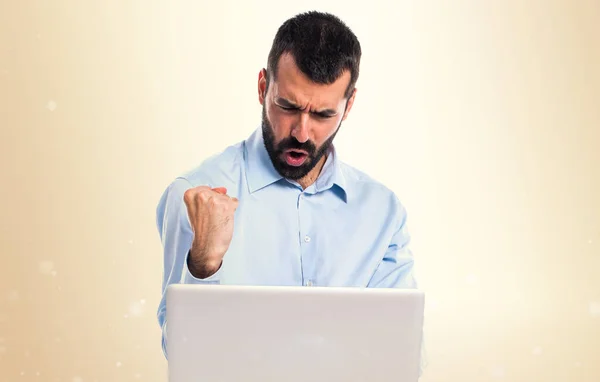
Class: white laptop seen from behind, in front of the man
167,284,424,382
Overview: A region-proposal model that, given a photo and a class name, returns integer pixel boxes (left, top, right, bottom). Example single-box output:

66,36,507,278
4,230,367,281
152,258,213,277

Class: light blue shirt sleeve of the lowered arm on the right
368,199,427,377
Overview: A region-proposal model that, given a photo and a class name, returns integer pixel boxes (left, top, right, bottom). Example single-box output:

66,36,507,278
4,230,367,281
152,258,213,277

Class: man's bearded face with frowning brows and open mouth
259,55,354,180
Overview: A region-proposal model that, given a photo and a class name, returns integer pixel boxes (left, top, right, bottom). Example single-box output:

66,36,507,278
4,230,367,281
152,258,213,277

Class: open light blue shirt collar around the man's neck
244,126,348,202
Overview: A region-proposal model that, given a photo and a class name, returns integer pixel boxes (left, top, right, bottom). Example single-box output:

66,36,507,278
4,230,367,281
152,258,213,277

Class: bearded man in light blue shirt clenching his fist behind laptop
157,12,424,374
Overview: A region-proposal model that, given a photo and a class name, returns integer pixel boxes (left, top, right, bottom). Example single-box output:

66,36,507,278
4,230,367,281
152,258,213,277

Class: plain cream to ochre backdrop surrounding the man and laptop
0,0,600,382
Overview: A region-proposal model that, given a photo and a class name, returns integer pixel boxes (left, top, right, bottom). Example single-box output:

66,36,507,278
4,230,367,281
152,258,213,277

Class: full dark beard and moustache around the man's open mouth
262,104,342,180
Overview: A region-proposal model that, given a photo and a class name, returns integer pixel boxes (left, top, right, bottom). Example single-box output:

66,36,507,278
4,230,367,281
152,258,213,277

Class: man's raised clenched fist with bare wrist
183,186,239,278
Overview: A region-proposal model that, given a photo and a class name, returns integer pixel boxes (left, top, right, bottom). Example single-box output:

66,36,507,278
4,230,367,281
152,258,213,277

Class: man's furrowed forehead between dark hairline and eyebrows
273,54,350,108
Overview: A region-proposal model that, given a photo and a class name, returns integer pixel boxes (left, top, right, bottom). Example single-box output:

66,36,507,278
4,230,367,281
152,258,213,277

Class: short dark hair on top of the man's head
267,11,362,98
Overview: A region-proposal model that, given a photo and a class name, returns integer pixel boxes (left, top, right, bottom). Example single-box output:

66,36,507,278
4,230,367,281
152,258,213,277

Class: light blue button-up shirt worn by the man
156,128,426,374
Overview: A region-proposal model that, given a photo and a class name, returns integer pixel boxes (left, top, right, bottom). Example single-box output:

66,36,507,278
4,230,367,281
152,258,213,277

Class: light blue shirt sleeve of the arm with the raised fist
156,178,222,358
